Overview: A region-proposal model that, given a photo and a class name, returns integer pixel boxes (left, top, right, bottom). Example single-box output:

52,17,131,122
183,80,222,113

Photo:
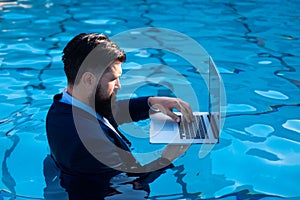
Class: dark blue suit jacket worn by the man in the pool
46,94,170,199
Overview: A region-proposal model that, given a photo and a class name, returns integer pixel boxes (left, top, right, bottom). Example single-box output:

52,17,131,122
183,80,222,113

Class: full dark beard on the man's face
95,86,117,118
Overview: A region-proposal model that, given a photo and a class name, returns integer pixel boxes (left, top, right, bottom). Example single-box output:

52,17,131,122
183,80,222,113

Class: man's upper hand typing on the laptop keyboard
148,97,194,122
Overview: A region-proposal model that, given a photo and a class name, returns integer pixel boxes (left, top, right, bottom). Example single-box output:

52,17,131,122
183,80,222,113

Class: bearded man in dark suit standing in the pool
45,33,193,199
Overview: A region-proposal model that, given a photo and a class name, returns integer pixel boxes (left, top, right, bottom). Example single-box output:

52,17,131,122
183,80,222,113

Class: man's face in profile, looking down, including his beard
95,61,122,117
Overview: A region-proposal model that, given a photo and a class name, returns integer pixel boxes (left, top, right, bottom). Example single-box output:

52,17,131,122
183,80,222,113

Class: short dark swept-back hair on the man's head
62,33,126,84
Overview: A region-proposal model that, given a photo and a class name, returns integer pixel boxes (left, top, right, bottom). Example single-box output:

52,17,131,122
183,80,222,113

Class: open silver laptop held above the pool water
150,57,220,144
